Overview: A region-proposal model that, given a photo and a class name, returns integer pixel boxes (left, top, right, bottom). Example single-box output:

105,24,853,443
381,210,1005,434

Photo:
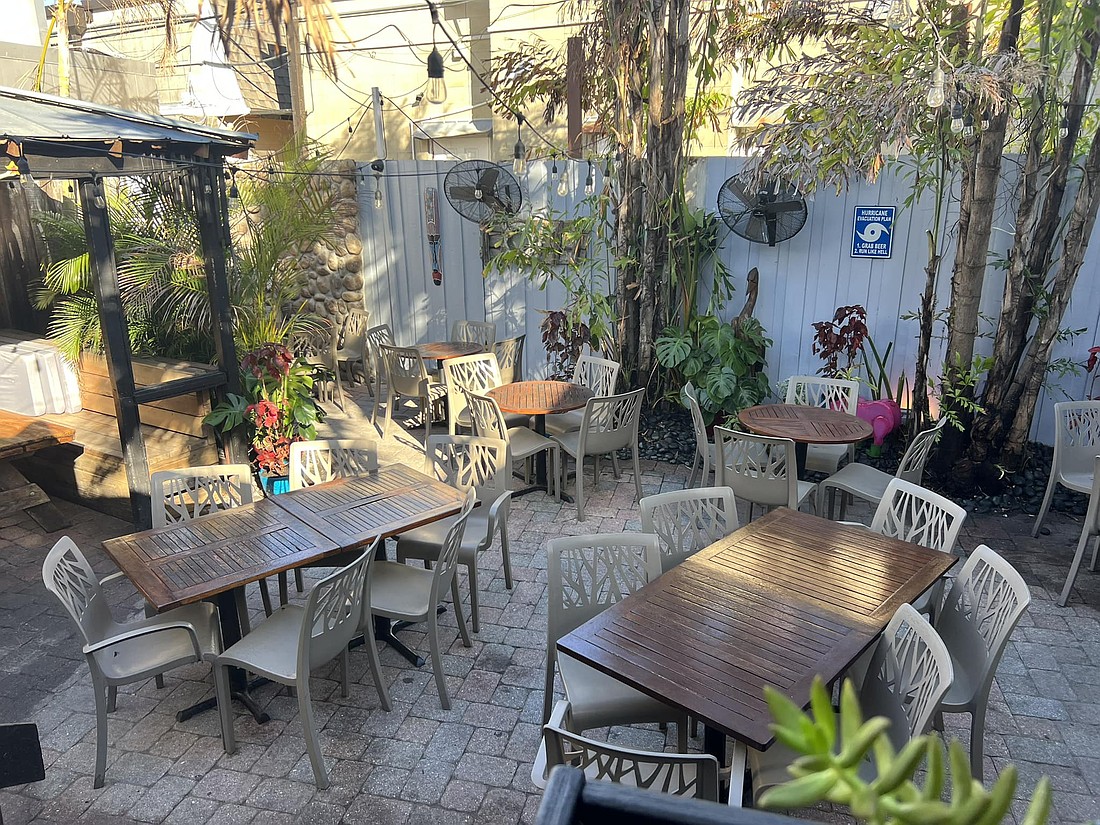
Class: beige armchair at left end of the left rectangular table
42,536,221,788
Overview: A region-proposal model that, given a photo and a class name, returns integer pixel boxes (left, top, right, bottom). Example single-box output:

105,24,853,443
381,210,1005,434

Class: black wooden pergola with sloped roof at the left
0,87,256,527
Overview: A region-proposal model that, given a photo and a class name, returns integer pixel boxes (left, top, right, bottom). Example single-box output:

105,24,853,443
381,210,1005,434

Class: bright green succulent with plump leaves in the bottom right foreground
760,677,1051,825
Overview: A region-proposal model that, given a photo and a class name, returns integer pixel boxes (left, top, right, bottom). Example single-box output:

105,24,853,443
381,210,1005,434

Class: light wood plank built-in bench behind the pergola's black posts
20,353,218,521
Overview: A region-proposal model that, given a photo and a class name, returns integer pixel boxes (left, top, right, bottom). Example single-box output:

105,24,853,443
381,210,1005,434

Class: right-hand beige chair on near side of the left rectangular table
363,490,476,711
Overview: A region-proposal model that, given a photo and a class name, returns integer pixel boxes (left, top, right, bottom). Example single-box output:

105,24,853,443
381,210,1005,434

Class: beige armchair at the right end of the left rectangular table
397,436,512,633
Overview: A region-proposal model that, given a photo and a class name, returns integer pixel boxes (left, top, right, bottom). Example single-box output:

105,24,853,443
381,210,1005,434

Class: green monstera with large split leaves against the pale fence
657,315,771,425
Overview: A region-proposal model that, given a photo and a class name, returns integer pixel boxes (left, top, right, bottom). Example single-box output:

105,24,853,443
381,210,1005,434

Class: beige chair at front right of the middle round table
553,388,646,521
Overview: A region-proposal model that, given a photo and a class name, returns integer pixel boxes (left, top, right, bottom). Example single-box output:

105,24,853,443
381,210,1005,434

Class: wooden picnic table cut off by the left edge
0,409,76,532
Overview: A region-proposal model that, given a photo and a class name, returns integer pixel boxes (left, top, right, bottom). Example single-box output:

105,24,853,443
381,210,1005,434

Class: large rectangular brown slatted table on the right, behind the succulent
558,507,955,809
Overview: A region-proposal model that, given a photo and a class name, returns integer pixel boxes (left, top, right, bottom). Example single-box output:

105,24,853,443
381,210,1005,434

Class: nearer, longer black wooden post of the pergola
80,179,152,529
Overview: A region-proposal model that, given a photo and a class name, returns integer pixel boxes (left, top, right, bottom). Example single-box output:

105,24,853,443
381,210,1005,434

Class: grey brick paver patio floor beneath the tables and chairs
0,398,1100,825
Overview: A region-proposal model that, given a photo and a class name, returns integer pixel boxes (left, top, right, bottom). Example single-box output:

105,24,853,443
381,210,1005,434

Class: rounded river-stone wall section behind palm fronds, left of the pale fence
298,161,363,325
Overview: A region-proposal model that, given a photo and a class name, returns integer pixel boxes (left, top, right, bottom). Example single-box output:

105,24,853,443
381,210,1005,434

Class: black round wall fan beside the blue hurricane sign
718,172,806,246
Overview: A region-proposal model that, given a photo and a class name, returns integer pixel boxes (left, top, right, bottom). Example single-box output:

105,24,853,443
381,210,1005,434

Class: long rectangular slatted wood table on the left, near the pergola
103,464,464,722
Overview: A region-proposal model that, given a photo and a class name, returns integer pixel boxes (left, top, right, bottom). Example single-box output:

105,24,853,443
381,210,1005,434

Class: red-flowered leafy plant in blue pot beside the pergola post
204,343,327,475
